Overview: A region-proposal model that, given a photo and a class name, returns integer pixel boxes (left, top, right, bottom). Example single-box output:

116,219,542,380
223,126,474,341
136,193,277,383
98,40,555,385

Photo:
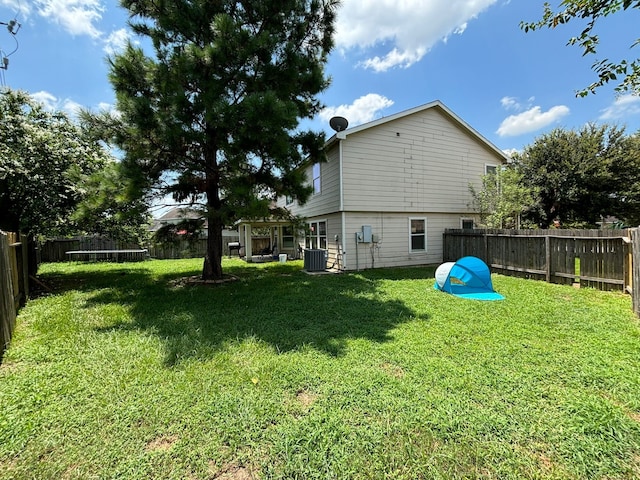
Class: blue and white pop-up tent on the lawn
434,257,504,300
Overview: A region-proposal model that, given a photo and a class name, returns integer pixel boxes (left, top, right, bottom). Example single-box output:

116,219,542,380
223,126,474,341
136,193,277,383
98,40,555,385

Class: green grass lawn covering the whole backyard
0,260,640,479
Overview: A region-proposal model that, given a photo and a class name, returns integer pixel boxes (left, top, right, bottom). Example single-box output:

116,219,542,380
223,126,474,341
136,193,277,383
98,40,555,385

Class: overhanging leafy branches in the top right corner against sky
520,0,640,97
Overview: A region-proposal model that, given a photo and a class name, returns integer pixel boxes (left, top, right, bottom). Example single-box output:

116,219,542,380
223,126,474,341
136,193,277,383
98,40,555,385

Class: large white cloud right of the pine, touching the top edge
336,0,497,71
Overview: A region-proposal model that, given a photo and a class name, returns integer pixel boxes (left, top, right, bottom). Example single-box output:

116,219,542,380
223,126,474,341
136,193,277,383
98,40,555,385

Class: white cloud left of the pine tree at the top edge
35,0,105,38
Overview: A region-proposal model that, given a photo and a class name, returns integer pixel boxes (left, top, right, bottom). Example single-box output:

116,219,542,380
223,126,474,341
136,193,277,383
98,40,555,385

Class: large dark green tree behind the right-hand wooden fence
517,125,640,226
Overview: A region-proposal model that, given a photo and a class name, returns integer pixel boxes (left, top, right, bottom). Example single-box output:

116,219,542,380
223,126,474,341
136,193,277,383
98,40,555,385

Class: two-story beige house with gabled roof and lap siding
239,101,508,270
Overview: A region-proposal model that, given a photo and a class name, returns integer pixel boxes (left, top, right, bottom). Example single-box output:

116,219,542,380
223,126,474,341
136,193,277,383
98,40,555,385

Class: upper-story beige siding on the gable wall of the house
343,109,496,213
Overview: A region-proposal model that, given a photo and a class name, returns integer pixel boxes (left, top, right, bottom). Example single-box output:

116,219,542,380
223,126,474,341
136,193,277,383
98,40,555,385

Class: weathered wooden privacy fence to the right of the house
443,229,640,293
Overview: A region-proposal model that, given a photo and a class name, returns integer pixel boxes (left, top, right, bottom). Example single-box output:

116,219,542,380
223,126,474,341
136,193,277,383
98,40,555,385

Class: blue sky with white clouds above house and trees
0,0,640,155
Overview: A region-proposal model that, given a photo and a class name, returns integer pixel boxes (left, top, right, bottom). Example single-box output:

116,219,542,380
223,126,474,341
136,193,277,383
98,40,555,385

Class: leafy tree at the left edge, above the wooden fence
0,90,110,238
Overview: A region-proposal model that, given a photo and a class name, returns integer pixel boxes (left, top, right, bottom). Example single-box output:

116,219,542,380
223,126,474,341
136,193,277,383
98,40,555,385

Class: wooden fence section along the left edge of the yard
0,231,29,360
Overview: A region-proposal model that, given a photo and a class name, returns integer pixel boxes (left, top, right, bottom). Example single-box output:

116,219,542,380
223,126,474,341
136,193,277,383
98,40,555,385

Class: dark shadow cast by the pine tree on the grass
50,264,433,365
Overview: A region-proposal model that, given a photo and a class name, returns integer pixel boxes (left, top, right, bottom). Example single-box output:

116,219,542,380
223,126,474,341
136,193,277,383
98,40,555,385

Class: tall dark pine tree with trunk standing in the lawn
110,0,338,279
